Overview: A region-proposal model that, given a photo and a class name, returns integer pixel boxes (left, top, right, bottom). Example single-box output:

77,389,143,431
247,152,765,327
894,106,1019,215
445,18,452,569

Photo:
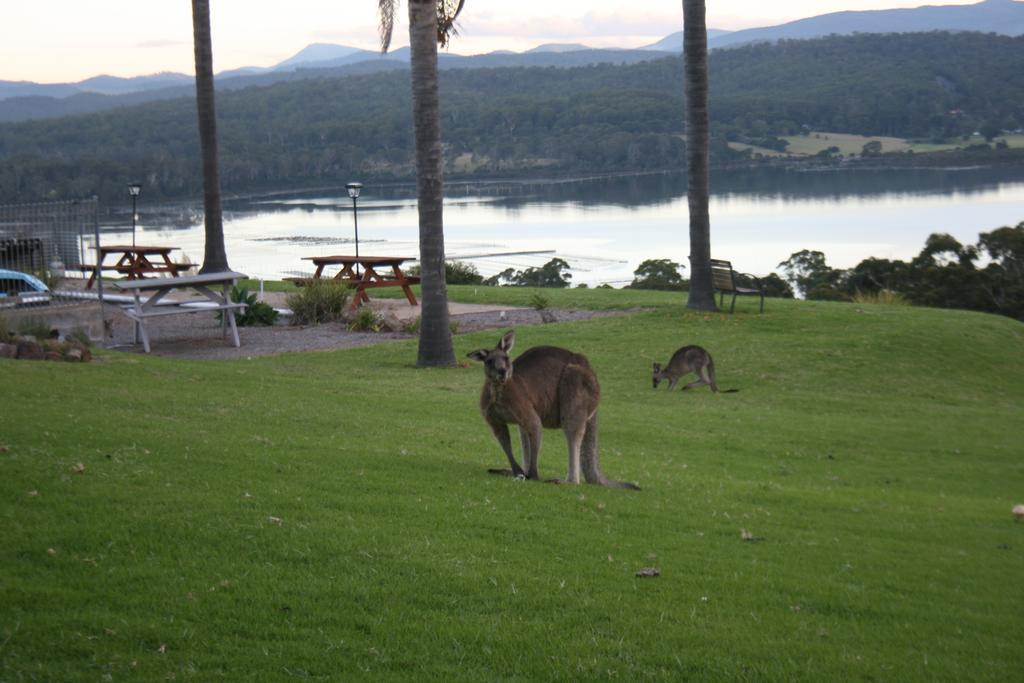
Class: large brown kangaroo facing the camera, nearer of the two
468,332,640,490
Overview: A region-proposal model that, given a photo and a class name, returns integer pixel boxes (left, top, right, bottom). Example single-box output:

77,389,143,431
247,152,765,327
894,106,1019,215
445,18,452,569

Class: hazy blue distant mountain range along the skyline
0,0,1024,122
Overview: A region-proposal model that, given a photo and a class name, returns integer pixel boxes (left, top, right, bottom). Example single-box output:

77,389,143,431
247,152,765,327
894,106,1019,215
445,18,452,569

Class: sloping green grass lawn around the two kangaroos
0,287,1024,681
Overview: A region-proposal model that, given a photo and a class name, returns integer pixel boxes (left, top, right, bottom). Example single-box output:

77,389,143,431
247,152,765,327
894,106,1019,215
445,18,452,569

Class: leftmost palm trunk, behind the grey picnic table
193,0,230,272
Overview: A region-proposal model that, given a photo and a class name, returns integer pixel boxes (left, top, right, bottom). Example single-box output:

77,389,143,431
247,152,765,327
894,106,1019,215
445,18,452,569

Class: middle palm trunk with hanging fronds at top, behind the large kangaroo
409,0,456,367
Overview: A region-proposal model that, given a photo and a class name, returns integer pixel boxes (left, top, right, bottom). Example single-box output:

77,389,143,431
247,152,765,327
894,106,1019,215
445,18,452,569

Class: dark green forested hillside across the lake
0,33,1024,202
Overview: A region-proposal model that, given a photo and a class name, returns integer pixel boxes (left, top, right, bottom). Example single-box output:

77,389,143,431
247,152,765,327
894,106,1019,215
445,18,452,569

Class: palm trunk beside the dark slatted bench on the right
683,0,718,310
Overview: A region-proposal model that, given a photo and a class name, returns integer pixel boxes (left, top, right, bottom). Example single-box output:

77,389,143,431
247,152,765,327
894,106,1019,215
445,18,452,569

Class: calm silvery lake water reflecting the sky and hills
101,169,1024,286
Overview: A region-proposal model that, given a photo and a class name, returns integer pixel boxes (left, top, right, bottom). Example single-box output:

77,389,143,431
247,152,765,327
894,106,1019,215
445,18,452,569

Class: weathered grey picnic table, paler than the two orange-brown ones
114,270,246,353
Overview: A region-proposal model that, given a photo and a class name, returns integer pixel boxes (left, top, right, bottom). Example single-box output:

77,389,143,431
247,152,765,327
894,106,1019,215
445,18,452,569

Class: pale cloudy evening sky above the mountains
0,0,978,83
